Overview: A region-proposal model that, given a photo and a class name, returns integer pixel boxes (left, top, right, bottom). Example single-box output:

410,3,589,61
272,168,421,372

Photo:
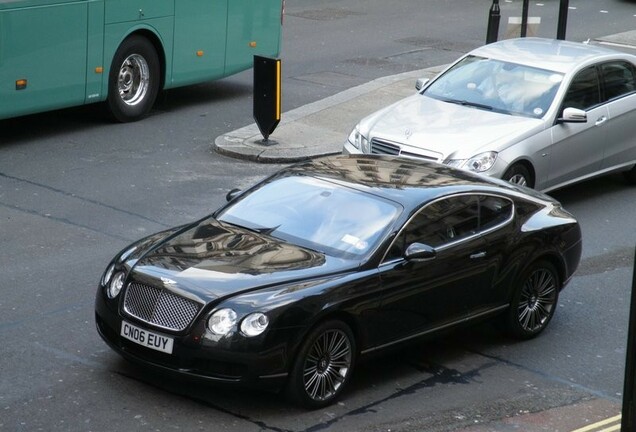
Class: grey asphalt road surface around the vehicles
0,0,636,431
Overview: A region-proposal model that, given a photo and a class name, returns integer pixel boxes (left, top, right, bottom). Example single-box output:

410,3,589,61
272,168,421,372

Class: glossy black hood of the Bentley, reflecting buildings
125,218,358,302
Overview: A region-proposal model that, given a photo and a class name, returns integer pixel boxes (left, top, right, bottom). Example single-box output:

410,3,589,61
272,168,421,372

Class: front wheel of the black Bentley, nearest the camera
286,321,356,409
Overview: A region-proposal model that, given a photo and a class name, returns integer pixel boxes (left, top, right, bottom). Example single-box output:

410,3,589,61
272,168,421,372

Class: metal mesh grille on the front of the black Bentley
124,282,200,331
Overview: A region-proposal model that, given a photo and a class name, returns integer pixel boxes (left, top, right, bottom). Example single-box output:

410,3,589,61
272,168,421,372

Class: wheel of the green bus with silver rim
108,36,160,122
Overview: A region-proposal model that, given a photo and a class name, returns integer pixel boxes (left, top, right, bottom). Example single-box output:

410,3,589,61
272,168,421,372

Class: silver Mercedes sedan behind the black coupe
343,38,636,191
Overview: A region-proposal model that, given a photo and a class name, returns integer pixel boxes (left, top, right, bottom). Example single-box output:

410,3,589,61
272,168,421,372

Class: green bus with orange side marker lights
0,0,284,122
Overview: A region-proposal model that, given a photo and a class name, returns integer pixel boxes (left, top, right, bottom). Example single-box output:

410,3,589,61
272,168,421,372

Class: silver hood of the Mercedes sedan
359,94,545,162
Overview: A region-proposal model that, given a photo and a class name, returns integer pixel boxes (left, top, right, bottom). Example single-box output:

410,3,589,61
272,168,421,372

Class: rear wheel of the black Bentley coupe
505,261,560,339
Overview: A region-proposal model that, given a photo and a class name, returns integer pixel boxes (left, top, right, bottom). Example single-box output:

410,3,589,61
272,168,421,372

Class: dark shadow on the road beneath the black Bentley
103,322,510,416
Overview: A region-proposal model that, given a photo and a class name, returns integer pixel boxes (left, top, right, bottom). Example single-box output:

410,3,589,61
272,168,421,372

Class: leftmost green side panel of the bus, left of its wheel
0,0,88,118
